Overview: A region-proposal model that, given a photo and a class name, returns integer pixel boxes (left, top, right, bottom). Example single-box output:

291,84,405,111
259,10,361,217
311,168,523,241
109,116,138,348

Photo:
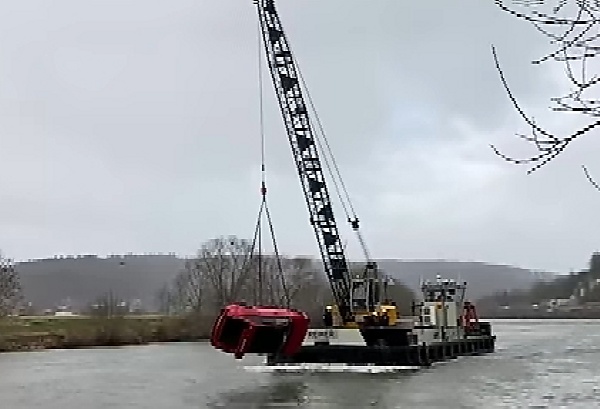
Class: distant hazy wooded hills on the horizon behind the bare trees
17,255,556,309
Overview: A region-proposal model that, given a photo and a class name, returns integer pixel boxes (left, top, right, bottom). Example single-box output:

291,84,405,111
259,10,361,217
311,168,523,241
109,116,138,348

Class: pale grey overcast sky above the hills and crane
0,0,600,272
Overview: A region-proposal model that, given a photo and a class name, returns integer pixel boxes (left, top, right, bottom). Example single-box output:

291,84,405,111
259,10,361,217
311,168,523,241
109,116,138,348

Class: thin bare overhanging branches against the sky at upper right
492,0,600,191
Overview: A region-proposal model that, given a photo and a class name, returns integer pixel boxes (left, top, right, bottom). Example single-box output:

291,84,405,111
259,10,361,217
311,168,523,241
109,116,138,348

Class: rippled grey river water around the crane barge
0,320,600,409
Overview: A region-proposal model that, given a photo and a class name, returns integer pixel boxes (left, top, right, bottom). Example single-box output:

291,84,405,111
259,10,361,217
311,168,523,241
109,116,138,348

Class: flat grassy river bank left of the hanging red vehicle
0,316,212,352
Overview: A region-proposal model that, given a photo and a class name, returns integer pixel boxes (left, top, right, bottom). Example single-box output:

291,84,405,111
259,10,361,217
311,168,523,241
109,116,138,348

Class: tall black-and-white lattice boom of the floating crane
254,0,352,321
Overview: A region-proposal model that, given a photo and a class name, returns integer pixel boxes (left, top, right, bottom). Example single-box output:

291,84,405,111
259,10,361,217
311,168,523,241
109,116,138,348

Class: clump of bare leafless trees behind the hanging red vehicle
160,236,329,315
